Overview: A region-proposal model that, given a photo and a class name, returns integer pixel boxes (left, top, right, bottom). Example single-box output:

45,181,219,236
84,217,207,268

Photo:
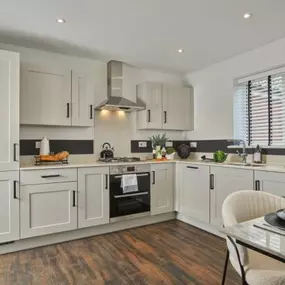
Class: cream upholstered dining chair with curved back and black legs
222,190,285,285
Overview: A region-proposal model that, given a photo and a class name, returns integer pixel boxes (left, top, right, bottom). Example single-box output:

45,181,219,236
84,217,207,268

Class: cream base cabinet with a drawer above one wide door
20,167,78,238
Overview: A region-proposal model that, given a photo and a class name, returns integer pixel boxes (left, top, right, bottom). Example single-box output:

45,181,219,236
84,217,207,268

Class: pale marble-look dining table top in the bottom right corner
221,217,285,263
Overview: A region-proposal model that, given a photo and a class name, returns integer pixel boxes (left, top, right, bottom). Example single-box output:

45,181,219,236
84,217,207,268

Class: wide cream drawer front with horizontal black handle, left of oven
20,168,77,185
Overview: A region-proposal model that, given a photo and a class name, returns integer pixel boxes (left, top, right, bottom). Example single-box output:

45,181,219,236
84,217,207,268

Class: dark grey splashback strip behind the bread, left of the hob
20,140,94,155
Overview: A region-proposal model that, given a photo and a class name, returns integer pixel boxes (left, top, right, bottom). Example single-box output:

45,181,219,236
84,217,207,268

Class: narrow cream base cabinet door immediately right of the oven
150,163,174,215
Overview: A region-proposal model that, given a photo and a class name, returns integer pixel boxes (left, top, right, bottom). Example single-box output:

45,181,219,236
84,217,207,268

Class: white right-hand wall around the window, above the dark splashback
186,38,285,140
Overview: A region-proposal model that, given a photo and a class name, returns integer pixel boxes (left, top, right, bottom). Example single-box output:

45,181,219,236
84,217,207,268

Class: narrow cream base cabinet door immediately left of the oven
78,167,109,228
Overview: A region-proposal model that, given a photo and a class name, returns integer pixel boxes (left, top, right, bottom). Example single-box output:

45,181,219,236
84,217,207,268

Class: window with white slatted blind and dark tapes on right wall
234,68,285,147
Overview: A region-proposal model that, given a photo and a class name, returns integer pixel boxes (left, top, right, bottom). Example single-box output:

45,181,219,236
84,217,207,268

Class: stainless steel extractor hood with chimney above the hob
95,60,145,112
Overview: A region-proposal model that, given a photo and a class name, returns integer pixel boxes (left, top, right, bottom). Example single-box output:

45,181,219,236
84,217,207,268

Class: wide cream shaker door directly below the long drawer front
20,182,77,238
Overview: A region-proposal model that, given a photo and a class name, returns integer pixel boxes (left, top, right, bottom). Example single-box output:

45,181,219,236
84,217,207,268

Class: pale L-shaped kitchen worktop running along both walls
20,156,285,172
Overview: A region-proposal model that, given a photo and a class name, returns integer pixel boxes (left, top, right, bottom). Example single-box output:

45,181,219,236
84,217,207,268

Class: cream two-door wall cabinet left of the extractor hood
20,63,102,127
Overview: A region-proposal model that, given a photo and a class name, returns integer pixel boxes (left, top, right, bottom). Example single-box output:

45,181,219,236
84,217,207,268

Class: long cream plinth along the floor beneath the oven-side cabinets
0,212,176,254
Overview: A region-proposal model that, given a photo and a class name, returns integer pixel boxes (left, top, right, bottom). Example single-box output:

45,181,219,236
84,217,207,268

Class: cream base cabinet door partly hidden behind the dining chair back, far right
255,171,285,198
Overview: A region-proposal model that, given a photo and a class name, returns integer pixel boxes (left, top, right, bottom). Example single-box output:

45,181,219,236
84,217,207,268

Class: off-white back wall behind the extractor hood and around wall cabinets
0,44,184,156
